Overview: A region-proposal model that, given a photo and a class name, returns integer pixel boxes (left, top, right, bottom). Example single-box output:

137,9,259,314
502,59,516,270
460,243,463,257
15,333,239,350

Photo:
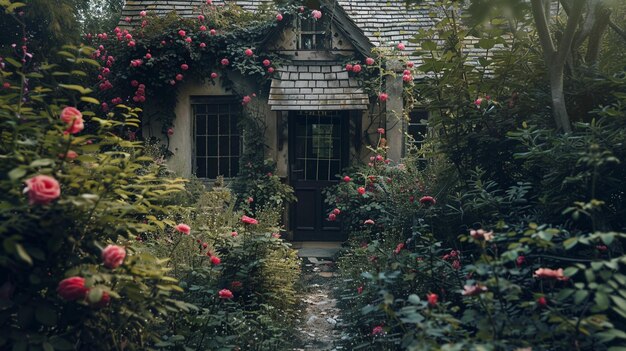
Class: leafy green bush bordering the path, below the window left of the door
145,188,300,350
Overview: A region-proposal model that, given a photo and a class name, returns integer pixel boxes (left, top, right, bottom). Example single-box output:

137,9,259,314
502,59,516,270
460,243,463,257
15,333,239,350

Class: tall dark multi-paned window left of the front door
191,97,241,179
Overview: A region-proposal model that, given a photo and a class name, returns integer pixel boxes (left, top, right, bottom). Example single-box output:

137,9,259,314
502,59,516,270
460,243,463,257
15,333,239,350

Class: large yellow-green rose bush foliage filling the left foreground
0,47,192,350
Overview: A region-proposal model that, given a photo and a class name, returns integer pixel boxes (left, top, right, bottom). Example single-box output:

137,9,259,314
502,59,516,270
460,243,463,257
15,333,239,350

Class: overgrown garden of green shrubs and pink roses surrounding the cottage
0,0,626,351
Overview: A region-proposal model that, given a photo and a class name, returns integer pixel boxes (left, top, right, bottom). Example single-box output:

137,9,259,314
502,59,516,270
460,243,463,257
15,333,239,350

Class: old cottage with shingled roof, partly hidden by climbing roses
123,0,432,240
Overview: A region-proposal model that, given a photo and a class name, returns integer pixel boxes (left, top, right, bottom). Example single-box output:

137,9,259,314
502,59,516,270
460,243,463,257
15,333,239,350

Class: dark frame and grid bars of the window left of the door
189,95,243,181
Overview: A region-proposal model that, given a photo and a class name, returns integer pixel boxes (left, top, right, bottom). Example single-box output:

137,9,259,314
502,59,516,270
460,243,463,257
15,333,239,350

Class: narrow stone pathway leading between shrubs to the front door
293,257,342,351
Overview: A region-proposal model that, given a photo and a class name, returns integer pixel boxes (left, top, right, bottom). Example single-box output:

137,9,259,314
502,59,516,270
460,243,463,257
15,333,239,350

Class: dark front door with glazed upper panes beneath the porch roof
289,111,349,241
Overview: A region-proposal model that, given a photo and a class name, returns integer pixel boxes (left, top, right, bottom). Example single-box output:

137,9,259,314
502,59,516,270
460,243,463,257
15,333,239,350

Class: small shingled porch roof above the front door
269,61,369,111
